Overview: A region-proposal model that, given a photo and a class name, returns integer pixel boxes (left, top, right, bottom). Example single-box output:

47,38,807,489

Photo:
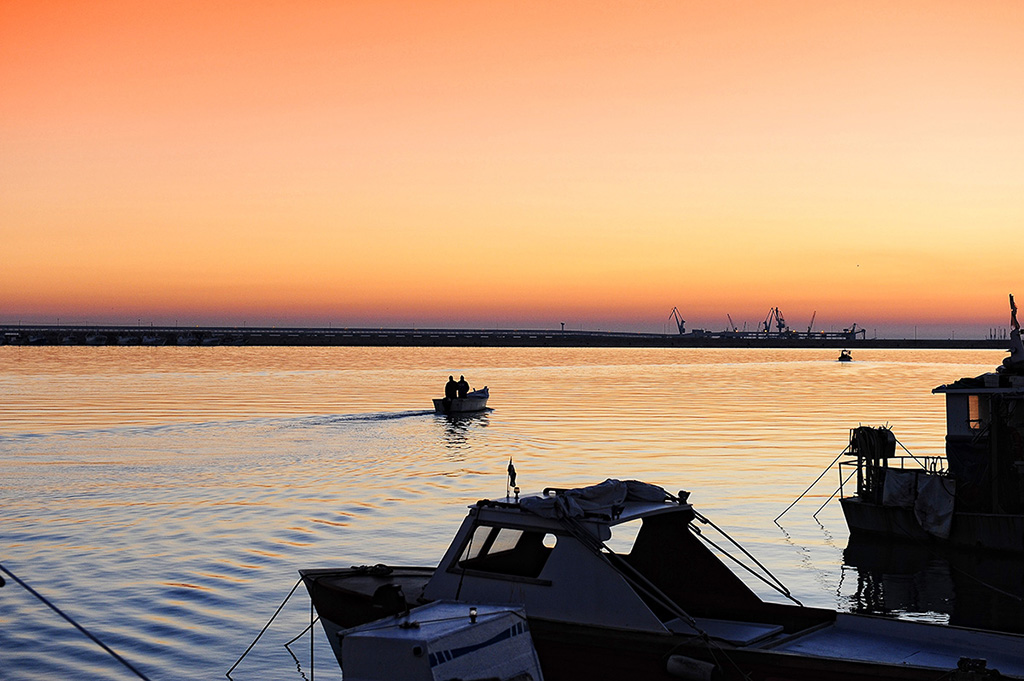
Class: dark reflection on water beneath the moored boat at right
843,537,1024,633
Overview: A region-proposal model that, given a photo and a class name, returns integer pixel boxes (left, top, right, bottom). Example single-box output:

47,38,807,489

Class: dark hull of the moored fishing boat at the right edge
840,497,1024,553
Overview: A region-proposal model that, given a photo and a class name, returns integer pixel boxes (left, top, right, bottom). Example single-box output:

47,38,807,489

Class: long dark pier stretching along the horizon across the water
0,325,1010,350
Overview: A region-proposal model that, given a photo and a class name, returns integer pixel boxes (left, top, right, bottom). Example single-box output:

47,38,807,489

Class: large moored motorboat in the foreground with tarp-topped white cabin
299,479,1024,681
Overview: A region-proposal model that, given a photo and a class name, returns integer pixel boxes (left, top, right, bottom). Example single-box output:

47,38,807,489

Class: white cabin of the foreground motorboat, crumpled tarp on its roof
423,480,827,645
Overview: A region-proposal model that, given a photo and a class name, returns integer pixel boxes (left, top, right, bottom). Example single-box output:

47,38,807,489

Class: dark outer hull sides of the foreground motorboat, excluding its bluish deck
300,566,1021,681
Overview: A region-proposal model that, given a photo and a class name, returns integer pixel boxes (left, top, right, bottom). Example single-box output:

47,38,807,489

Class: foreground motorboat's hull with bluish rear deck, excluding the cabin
300,566,1024,681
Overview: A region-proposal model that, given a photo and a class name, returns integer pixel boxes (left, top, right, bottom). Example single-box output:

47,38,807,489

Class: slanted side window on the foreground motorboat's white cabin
458,525,557,579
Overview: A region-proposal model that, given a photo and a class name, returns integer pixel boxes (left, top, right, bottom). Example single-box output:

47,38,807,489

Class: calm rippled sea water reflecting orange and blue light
0,346,1024,680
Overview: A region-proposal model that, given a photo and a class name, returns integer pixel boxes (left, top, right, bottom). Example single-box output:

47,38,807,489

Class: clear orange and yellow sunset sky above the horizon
0,0,1024,337
